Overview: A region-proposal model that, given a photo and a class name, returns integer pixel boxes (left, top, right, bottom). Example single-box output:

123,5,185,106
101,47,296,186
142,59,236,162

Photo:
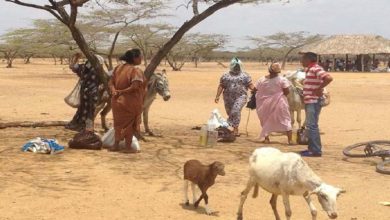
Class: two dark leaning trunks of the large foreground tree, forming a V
5,0,288,79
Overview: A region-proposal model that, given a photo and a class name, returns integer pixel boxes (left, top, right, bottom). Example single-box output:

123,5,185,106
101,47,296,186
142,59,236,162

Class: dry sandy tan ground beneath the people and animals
0,60,390,220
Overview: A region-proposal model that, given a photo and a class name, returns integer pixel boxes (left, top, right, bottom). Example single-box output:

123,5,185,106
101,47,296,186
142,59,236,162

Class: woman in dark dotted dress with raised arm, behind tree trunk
66,53,104,131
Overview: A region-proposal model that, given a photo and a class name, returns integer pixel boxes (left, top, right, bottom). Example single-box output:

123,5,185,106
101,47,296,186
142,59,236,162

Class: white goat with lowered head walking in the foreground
237,147,345,220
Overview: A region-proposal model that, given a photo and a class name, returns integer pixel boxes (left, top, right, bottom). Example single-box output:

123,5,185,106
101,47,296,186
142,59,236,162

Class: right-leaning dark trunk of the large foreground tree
145,0,241,78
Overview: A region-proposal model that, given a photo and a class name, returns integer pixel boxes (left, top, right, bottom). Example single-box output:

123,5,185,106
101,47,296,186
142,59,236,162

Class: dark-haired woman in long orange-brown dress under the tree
109,49,147,153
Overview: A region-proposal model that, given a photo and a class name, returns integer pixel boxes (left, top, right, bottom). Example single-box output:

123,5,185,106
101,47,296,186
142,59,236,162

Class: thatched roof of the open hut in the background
300,35,390,55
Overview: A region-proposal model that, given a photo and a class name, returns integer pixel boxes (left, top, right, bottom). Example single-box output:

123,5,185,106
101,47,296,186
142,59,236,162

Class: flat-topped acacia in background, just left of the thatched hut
249,31,323,69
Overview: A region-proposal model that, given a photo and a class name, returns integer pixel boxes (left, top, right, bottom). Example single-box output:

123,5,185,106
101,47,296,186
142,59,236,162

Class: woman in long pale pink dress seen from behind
256,63,292,144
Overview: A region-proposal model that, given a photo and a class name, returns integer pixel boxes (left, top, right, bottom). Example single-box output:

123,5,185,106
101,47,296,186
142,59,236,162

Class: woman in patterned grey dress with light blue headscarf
215,58,255,136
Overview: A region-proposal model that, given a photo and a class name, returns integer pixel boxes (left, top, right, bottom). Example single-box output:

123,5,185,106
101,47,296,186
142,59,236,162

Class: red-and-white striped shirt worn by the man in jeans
303,63,329,104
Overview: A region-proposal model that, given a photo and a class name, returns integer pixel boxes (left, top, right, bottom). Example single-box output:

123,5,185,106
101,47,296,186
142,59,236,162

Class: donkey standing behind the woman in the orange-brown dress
95,71,171,136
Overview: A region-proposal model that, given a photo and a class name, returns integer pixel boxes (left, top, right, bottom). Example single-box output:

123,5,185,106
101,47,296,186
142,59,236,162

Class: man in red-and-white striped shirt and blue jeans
301,52,333,157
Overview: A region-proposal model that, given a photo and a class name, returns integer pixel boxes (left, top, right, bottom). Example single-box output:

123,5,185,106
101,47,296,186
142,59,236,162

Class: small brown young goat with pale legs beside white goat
184,160,225,215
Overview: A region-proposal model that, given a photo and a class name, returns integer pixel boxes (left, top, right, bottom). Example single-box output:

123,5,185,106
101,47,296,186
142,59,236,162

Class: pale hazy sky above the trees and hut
0,0,390,50
